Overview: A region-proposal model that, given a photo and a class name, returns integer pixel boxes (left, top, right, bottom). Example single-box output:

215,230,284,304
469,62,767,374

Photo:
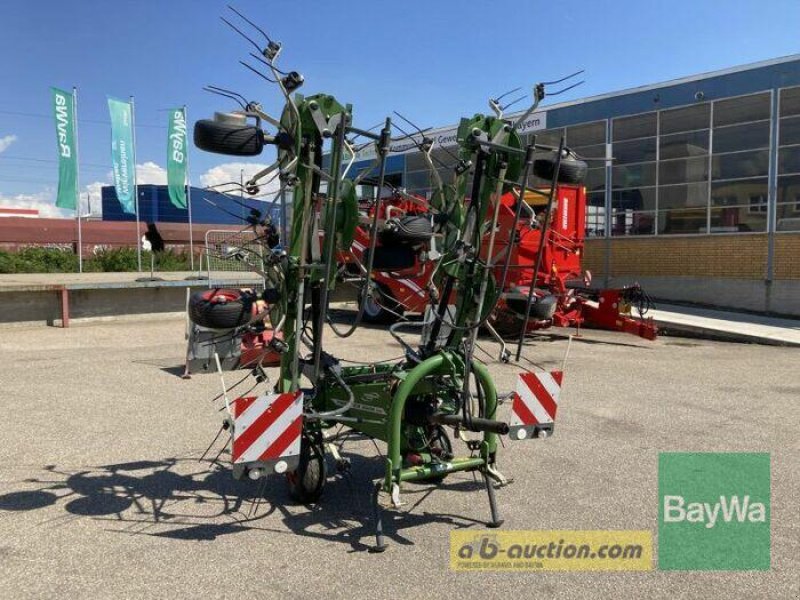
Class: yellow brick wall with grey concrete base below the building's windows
583,233,800,316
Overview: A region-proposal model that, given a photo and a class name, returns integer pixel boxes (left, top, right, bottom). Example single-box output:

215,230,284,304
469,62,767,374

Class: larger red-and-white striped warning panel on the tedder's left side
231,391,303,473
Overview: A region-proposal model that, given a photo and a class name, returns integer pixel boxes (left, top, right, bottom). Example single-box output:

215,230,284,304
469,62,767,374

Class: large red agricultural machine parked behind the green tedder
340,183,657,340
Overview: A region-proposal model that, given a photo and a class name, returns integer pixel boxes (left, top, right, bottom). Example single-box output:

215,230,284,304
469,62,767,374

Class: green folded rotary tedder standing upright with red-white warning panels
194,11,586,550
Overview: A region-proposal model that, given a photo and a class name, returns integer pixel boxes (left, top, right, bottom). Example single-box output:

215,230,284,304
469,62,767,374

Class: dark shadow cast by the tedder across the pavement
0,452,482,551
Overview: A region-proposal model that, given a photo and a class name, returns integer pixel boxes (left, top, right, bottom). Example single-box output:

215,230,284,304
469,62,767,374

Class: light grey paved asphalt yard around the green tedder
0,321,800,599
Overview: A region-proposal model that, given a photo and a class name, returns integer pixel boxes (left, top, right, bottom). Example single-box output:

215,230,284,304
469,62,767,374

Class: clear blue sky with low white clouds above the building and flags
0,0,800,216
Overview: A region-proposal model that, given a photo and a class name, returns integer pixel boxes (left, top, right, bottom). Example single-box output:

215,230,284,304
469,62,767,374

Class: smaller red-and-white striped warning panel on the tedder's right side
508,371,564,440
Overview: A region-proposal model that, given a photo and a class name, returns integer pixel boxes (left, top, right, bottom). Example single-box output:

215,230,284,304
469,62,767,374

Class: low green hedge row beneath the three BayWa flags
0,246,189,273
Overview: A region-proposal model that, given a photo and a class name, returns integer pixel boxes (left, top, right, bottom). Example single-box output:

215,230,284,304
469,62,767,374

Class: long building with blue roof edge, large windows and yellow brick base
352,55,800,315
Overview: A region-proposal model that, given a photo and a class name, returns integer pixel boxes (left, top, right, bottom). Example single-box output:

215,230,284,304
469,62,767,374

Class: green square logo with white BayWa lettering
658,452,770,570
